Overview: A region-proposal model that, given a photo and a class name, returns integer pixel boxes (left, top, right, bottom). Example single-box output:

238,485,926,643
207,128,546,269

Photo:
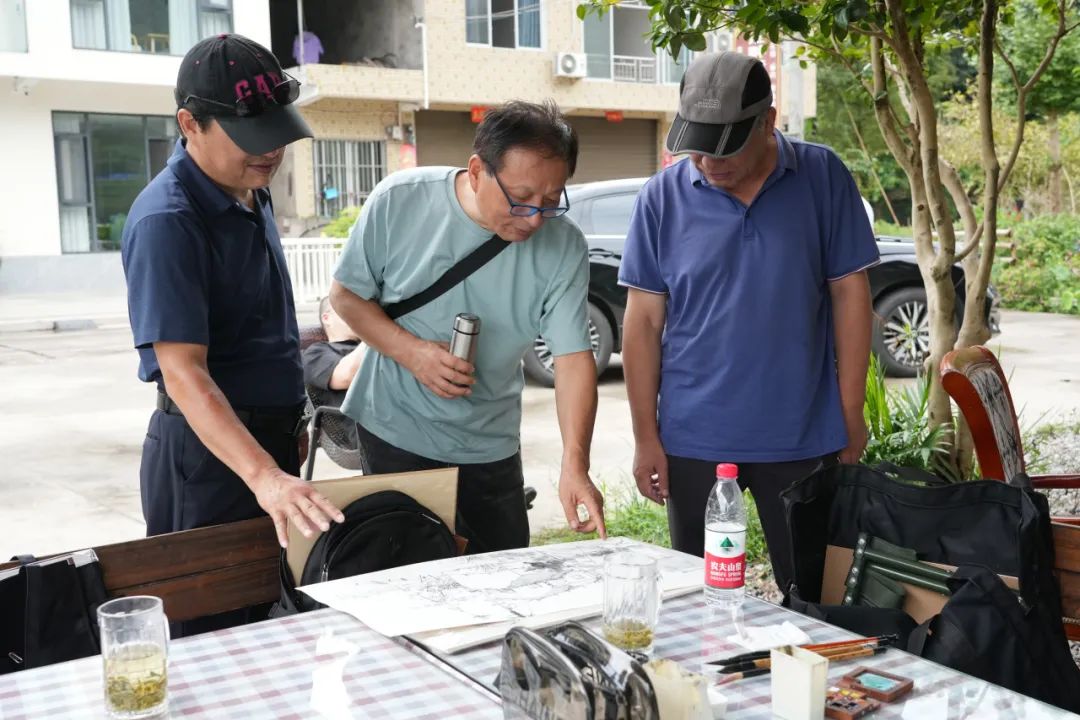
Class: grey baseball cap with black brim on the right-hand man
666,52,772,158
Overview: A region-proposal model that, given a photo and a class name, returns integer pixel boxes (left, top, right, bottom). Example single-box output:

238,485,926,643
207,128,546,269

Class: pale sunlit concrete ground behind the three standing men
0,306,1080,558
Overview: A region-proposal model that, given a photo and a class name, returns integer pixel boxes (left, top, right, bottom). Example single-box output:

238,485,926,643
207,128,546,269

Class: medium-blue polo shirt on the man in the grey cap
619,132,878,462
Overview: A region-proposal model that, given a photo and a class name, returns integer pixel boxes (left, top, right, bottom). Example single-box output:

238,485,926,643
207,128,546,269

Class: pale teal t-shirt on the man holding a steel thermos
334,167,590,464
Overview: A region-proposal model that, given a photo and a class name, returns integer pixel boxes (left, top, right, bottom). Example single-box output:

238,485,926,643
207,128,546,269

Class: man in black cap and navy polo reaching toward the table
122,35,343,569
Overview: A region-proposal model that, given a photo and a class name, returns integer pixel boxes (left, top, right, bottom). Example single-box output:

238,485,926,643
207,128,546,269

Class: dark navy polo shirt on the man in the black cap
121,141,303,407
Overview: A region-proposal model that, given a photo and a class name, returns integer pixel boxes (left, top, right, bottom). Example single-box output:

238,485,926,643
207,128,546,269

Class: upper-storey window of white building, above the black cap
71,0,232,55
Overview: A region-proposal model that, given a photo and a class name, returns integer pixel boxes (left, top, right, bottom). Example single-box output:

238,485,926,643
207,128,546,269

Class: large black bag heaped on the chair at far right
781,465,1080,711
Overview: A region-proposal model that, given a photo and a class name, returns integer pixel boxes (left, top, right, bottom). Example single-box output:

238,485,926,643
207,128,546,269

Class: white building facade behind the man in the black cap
0,0,270,293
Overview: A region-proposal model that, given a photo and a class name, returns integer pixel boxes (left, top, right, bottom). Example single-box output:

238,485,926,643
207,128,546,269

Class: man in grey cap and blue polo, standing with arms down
619,53,878,593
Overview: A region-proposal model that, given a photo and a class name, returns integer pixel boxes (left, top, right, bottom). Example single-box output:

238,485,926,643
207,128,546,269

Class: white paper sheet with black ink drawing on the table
300,538,703,636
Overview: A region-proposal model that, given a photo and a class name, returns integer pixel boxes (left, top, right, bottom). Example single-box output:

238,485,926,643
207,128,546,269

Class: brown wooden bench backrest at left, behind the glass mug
0,517,281,622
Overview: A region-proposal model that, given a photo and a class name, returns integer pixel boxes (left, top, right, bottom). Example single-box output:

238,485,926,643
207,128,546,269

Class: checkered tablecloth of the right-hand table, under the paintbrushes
425,593,1076,720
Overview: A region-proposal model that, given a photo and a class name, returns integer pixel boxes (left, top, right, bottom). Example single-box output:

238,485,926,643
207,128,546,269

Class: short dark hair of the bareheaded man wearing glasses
473,100,578,177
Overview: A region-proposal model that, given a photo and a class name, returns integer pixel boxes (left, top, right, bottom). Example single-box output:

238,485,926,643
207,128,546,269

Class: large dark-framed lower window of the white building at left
53,112,176,253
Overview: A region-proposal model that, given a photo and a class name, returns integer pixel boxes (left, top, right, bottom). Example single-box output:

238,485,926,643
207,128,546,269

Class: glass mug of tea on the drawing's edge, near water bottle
602,553,660,654
